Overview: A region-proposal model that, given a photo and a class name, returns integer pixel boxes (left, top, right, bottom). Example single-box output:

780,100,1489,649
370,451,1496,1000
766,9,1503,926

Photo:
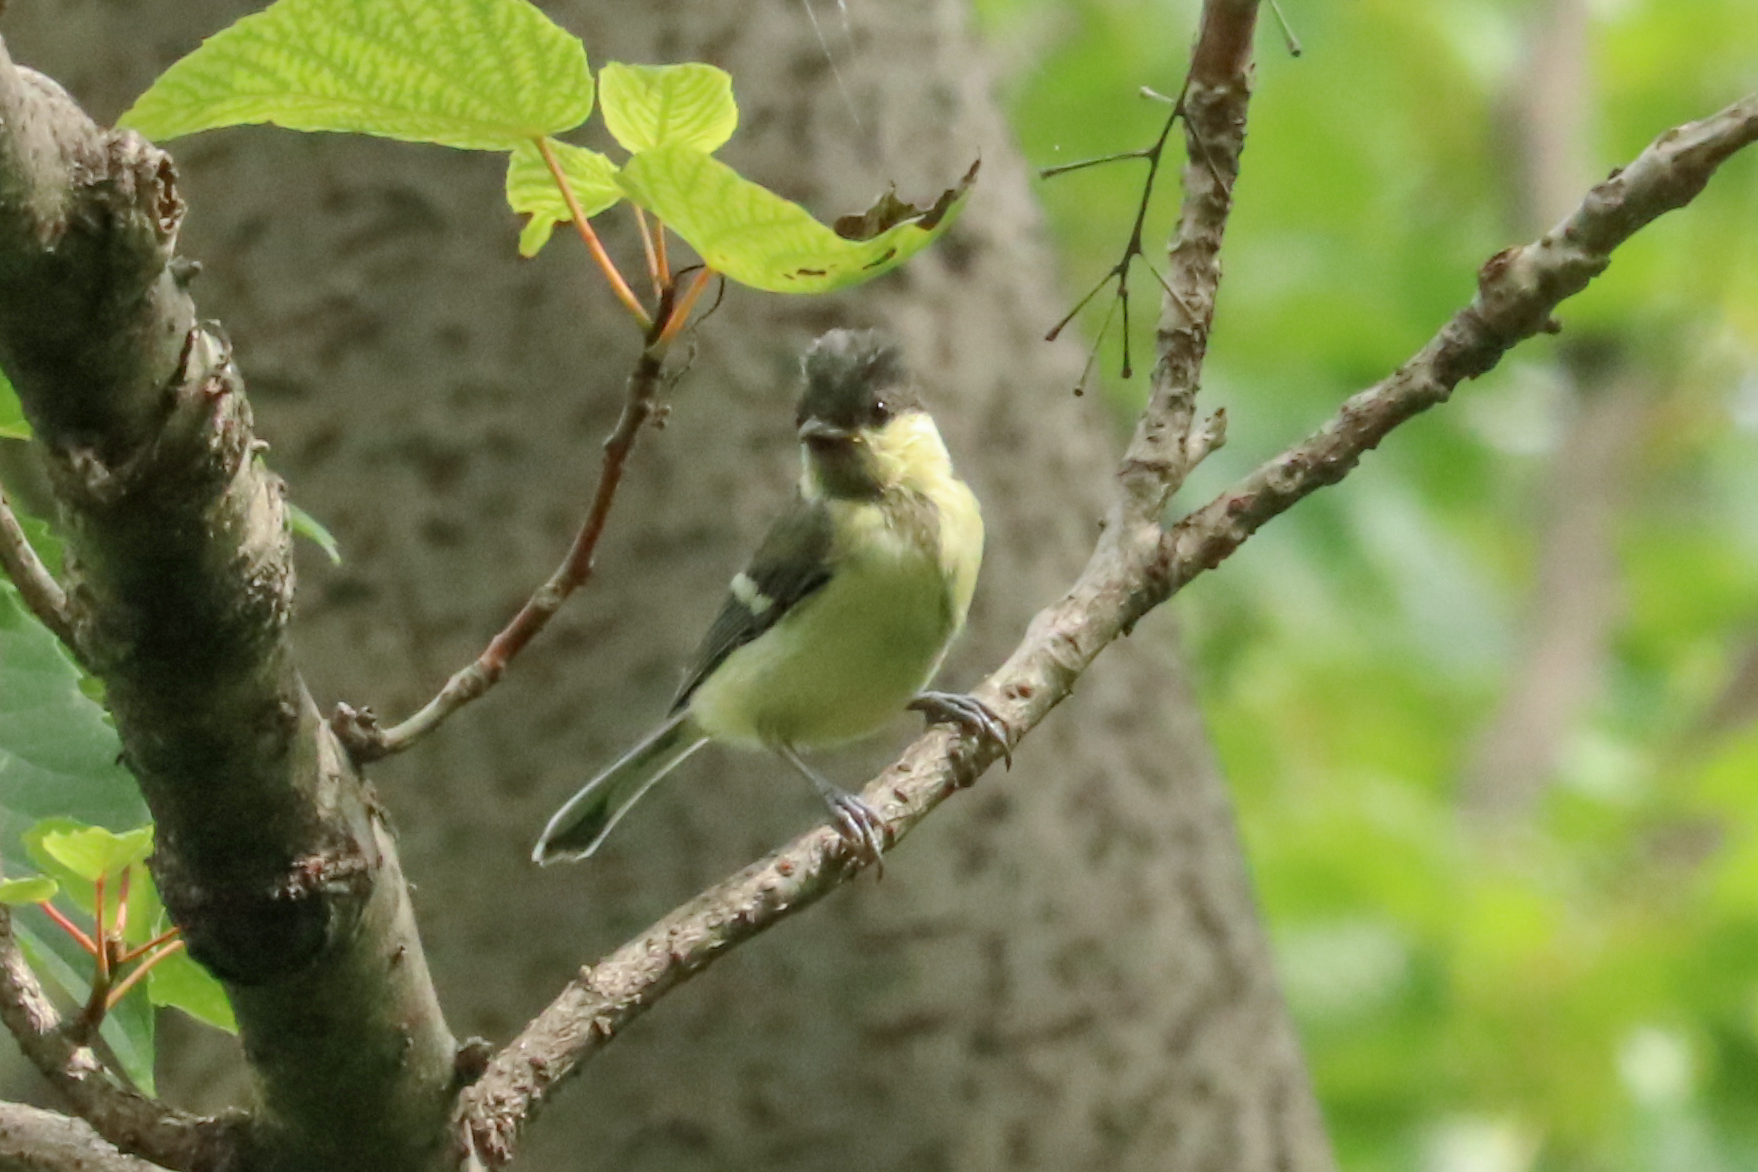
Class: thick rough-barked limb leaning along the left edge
0,41,454,1170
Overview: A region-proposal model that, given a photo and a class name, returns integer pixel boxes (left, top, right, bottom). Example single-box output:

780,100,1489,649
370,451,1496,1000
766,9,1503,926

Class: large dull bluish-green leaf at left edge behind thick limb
0,580,148,878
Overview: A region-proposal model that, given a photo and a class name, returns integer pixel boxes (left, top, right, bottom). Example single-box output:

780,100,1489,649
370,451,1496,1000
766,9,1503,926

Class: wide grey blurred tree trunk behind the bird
5,0,1331,1172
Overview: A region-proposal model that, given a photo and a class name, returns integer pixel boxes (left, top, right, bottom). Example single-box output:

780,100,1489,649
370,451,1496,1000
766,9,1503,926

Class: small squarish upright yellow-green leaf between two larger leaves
598,61,738,155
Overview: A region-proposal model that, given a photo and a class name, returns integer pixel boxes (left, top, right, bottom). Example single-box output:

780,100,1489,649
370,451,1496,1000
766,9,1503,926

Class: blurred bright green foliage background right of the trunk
979,0,1758,1172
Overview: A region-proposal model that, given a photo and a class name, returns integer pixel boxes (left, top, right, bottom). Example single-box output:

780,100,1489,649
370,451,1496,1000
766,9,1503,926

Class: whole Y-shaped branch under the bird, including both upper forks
459,36,1758,1163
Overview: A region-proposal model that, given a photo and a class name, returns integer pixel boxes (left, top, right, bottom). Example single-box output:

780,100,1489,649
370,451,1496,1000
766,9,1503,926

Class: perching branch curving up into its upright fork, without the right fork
459,0,1257,1165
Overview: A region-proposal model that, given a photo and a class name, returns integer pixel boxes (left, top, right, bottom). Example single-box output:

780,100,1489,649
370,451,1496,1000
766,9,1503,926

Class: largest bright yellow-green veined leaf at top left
118,0,592,151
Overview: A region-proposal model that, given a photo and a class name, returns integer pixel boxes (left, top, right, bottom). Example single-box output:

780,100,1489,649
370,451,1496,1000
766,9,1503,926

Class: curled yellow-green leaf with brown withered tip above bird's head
617,146,977,293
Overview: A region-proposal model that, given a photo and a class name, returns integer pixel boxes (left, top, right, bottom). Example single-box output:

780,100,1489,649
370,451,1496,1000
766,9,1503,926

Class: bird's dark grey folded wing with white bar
672,497,835,712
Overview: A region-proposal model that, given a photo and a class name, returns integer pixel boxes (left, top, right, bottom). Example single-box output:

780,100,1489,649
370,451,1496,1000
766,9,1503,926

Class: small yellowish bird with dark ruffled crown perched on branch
531,330,1007,865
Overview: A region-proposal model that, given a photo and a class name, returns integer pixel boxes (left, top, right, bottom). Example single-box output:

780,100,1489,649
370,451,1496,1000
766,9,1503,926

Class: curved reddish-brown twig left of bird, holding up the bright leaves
342,339,666,761
